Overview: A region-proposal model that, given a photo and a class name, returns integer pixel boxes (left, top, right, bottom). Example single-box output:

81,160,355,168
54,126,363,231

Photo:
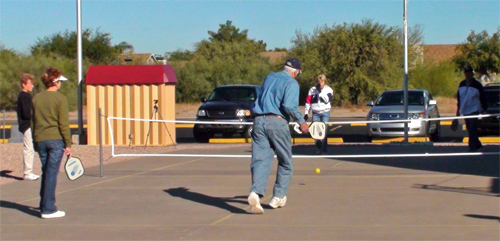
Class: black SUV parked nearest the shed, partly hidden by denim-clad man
193,85,260,143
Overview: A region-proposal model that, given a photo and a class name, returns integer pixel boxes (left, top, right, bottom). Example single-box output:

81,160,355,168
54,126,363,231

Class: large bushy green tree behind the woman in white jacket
289,20,421,105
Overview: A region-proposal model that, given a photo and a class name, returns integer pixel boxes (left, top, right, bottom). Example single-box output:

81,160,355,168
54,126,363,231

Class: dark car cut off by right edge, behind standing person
478,84,500,134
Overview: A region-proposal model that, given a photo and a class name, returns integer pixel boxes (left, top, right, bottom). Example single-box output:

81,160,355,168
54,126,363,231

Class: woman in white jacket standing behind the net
304,74,333,154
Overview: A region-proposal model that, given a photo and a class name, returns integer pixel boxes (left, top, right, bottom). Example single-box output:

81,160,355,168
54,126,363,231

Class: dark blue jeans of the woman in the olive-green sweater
36,140,65,214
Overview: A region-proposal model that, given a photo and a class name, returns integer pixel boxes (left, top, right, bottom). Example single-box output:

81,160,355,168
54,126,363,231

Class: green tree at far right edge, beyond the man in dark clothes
453,27,500,73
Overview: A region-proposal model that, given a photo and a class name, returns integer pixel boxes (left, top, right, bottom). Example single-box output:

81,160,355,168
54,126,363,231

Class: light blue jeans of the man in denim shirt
250,115,293,198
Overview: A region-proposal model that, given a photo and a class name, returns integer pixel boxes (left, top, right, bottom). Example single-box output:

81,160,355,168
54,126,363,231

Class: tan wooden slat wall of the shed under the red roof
87,85,176,146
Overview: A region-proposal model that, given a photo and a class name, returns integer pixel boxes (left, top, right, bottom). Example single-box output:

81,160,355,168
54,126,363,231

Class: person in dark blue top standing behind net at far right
457,67,488,152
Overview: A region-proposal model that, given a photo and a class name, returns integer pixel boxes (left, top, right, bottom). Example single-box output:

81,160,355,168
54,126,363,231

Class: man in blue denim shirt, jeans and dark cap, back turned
248,58,309,214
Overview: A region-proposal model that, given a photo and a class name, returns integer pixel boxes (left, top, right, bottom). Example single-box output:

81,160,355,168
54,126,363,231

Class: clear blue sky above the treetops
0,0,500,55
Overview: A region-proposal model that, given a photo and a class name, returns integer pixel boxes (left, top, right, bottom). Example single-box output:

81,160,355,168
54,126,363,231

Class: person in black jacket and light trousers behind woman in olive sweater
16,74,40,181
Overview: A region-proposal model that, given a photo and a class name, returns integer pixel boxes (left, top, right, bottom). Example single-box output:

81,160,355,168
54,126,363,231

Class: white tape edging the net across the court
106,114,499,158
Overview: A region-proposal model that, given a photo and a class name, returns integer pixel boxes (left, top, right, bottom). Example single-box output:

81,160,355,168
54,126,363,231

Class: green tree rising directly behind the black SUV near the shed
174,21,272,102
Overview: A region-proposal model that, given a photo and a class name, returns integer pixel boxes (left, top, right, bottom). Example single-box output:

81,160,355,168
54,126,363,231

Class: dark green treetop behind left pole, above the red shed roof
30,29,123,64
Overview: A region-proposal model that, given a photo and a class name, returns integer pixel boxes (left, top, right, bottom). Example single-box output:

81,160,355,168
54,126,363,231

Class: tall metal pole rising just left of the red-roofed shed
76,0,84,143
